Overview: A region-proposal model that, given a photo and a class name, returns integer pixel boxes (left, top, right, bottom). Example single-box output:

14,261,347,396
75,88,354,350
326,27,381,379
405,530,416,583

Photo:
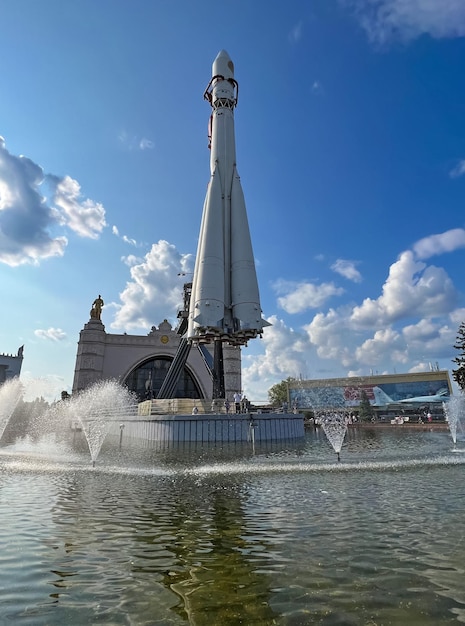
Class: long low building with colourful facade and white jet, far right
288,370,452,413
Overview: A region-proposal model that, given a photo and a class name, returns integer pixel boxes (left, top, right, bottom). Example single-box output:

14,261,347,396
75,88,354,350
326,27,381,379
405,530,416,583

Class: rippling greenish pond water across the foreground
0,427,465,626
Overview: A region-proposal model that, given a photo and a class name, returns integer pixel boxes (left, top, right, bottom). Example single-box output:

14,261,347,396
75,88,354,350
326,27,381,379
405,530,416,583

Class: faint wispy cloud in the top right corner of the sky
342,0,465,44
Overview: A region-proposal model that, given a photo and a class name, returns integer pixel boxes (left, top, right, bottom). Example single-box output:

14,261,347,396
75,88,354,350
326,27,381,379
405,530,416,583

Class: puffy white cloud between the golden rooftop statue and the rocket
111,240,192,330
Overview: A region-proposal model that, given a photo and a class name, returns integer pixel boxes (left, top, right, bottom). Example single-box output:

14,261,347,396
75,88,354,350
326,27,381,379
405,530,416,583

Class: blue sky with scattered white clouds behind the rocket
0,0,465,400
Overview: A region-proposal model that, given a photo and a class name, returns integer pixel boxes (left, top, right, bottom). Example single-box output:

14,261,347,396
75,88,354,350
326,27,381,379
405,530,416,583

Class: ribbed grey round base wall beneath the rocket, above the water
109,413,305,444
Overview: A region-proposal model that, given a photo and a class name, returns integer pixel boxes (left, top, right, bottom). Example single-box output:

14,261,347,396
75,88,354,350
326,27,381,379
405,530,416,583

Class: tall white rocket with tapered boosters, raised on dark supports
187,50,269,345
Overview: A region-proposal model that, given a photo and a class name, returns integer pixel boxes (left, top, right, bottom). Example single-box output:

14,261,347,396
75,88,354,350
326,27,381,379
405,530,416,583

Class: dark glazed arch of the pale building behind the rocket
124,356,203,401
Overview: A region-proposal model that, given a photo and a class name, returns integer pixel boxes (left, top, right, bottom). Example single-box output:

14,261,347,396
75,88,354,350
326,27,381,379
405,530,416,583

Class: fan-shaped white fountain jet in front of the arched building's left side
64,380,137,460
